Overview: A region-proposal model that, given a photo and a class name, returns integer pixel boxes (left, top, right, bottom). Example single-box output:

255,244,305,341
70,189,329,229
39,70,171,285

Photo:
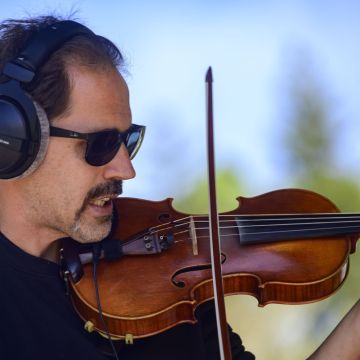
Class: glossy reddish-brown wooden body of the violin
65,189,356,338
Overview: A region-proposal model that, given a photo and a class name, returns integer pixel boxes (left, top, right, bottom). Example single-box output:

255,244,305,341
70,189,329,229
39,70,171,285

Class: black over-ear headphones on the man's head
0,20,94,179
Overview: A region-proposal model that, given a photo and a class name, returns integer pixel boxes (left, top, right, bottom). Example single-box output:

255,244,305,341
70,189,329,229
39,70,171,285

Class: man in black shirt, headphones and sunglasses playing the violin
0,17,254,360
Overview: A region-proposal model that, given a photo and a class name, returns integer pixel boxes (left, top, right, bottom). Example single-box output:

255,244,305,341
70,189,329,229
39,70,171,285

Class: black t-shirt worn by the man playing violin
0,234,254,360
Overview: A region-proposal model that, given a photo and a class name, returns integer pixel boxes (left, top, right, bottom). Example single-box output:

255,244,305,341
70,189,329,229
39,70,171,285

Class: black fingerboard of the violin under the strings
235,213,360,245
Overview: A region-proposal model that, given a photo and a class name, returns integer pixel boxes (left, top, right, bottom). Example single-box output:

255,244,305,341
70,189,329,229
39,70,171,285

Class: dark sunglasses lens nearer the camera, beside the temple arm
85,130,122,166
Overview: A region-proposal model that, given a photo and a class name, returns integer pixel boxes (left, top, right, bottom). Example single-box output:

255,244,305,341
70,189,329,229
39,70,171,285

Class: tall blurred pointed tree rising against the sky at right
283,57,337,182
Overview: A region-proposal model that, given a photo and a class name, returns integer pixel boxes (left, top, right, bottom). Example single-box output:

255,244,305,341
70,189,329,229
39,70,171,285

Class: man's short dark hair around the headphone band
0,16,124,120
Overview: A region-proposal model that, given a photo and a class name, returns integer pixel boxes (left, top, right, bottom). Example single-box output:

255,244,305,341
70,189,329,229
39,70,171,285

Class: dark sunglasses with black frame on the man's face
50,124,145,166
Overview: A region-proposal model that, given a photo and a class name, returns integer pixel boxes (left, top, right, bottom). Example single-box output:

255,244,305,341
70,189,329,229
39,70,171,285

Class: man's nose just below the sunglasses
104,144,136,180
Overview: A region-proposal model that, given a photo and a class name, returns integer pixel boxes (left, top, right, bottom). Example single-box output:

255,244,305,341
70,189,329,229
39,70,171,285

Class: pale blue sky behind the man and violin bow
1,0,360,199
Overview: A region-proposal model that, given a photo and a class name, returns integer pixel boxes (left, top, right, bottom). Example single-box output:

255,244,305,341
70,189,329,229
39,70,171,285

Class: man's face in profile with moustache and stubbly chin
18,68,135,242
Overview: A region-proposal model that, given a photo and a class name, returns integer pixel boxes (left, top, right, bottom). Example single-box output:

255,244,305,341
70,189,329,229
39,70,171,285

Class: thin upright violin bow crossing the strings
206,67,231,360
